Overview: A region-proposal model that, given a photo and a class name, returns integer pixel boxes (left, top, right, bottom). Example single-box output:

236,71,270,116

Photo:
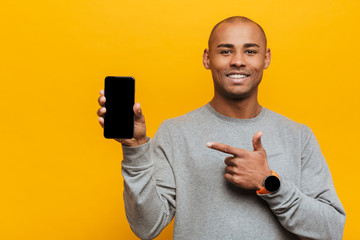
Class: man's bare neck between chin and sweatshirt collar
210,96,262,119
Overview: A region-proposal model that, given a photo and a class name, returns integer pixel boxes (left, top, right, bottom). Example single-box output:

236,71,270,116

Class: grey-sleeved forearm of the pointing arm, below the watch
261,179,345,240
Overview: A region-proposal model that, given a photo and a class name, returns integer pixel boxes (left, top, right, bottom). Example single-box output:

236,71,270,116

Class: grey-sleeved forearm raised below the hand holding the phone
122,143,175,239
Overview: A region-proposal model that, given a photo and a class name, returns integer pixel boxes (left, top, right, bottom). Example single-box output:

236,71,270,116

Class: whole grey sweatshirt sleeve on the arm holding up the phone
122,123,176,239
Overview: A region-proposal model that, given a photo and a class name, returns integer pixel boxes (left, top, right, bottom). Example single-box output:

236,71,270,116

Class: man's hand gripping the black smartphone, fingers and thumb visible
97,90,147,147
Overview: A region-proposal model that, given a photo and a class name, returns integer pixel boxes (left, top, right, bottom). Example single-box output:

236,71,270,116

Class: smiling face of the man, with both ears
203,21,271,99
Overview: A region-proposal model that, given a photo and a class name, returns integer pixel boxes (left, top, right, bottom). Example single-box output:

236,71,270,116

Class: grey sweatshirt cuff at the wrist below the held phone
121,137,152,168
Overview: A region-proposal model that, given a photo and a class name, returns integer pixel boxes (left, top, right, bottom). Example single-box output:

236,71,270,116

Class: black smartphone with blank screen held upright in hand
104,76,135,139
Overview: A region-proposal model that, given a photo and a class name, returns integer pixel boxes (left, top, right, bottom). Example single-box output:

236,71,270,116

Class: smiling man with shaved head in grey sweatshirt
98,17,345,240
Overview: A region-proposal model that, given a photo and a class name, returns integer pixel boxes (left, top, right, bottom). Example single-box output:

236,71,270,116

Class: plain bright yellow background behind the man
0,0,360,240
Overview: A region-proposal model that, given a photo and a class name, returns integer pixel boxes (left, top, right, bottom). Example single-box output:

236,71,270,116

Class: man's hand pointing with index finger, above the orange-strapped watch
206,131,271,190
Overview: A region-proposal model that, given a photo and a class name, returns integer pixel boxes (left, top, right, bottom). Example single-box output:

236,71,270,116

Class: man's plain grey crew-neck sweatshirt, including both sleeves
122,104,345,240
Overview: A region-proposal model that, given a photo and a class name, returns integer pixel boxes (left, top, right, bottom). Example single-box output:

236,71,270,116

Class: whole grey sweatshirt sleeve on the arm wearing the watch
259,125,345,240
